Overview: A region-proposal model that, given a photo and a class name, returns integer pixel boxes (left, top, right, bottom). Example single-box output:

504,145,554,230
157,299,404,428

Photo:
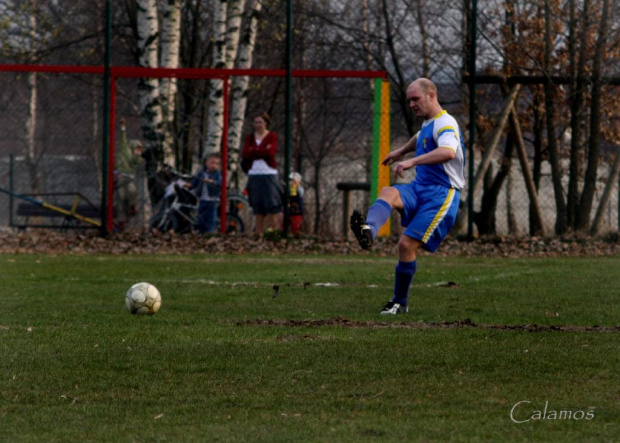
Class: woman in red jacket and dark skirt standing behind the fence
241,113,282,234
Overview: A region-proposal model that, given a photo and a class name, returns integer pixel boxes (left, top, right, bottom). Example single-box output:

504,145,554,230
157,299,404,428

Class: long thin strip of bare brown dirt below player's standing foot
236,317,620,332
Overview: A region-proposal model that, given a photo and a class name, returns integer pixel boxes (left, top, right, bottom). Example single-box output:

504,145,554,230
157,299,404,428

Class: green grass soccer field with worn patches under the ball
0,251,620,442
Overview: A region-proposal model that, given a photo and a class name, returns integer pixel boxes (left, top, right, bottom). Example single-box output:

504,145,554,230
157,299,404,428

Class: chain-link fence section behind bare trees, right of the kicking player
468,81,620,235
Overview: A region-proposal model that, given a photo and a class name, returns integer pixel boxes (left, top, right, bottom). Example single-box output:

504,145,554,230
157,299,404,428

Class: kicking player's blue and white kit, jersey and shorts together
394,111,465,252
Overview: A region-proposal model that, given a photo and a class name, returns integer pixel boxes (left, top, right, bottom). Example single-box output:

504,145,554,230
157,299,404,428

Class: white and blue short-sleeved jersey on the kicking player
415,111,465,190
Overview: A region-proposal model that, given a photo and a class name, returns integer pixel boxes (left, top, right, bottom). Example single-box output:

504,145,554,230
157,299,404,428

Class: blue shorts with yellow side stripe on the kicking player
394,182,461,252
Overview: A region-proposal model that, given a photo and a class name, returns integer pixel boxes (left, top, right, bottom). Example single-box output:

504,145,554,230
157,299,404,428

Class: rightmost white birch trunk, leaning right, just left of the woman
228,0,262,180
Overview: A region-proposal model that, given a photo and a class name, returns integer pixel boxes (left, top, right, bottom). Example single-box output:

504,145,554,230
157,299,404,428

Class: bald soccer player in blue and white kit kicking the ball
350,78,465,315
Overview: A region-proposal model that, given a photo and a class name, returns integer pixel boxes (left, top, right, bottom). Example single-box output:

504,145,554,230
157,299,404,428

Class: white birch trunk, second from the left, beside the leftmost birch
160,0,181,168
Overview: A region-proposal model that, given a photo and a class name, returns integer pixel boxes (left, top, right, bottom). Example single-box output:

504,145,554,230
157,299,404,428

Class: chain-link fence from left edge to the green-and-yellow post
0,67,382,236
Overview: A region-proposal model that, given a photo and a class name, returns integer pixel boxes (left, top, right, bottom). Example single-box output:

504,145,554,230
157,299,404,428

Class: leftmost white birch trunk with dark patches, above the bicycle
136,0,164,204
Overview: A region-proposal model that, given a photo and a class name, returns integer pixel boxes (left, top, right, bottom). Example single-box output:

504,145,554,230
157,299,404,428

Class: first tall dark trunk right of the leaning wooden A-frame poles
544,0,567,234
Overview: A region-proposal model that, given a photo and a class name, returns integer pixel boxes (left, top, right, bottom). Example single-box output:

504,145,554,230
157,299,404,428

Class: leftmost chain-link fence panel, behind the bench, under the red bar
0,72,102,227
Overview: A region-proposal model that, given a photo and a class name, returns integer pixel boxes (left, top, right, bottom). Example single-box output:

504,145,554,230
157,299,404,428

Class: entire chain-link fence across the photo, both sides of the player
0,66,619,236
